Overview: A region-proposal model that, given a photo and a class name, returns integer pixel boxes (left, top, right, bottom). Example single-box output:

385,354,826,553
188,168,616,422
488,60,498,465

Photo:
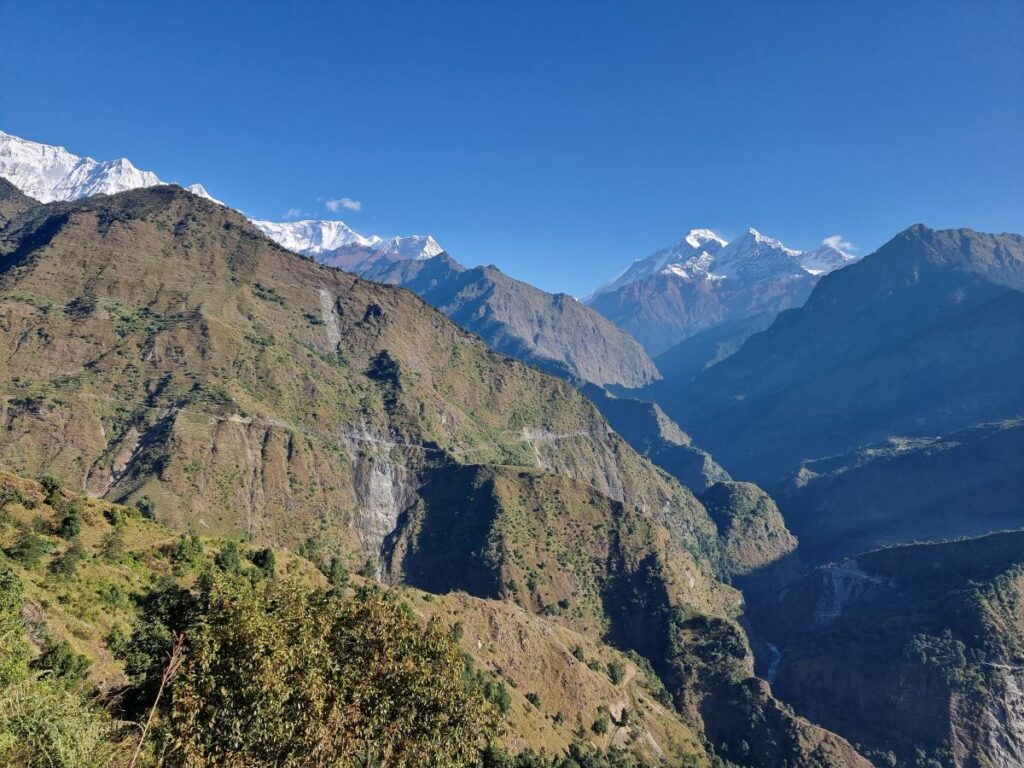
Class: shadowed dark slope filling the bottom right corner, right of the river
756,531,1024,768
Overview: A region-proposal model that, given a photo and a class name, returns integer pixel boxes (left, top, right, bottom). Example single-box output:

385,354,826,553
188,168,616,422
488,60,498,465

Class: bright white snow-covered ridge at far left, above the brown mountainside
0,131,213,203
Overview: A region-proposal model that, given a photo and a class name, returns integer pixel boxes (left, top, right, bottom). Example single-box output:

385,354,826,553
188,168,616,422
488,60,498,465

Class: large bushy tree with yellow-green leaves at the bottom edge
129,575,500,768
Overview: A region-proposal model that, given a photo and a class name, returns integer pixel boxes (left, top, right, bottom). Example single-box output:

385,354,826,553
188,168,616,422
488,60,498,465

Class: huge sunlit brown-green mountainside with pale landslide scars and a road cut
0,186,864,766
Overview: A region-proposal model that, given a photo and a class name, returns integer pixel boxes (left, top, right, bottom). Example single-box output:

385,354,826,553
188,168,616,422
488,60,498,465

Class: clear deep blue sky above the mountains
0,0,1024,295
